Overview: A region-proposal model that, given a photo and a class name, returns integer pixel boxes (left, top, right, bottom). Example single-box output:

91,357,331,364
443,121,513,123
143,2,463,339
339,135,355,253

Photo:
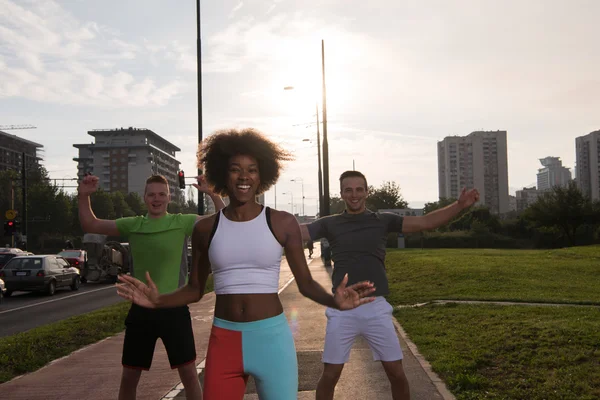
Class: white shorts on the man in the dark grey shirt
322,297,402,364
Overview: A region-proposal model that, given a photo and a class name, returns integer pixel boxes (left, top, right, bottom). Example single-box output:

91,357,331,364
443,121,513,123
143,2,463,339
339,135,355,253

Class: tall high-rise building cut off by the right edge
575,130,600,200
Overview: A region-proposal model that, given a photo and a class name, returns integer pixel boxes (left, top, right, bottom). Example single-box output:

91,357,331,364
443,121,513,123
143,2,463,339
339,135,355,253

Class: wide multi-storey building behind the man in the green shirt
73,127,180,197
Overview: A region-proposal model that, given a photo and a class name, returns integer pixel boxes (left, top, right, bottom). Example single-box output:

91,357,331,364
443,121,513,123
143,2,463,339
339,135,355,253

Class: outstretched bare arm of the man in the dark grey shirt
402,188,479,233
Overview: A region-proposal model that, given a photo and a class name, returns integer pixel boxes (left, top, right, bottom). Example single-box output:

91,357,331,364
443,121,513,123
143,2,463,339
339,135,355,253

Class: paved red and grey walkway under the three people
0,246,452,400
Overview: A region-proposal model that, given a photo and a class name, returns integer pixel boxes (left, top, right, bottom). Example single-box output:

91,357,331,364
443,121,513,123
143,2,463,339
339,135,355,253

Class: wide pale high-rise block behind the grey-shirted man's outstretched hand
438,131,509,214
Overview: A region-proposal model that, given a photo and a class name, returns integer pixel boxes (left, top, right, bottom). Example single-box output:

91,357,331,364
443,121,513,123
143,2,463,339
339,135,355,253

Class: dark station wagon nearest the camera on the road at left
0,254,81,297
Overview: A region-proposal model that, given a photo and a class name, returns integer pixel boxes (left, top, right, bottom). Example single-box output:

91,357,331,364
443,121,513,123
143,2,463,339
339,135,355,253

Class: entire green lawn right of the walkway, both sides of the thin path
386,246,600,400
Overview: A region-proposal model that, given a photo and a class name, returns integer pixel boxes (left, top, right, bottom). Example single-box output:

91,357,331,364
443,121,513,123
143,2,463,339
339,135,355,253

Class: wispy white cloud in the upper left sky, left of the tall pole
0,0,184,107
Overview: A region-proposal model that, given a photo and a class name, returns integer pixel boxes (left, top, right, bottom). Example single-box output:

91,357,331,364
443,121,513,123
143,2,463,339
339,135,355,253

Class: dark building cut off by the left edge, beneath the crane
0,131,44,171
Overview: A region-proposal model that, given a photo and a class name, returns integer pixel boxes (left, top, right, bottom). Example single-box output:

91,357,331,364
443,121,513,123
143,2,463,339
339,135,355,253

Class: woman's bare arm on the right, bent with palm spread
271,210,375,309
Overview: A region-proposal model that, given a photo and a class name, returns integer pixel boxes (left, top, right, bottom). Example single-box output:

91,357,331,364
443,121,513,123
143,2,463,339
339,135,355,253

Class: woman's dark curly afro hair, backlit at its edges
197,128,294,196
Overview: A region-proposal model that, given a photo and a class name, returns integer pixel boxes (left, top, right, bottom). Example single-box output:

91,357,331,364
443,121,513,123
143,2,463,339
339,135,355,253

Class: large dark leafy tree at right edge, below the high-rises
523,182,600,245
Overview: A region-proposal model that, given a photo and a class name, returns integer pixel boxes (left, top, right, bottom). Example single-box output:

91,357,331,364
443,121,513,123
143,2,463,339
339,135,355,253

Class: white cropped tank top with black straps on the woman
208,207,283,294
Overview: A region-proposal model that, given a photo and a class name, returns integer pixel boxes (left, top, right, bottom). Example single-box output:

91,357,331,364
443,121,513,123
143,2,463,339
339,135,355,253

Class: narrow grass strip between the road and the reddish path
0,274,213,384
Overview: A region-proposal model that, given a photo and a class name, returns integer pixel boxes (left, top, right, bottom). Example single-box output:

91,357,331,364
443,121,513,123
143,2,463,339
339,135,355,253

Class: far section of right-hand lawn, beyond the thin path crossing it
386,246,600,304
